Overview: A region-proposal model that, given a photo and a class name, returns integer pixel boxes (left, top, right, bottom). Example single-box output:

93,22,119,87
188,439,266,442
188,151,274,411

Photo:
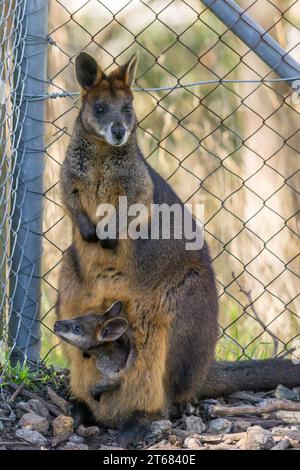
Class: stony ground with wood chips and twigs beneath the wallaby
0,368,300,450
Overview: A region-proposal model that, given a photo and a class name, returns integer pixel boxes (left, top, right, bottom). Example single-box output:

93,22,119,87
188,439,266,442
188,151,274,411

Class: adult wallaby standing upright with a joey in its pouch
57,53,300,446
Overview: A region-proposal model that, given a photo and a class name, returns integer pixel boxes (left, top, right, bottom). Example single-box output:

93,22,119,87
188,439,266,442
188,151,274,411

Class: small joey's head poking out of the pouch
54,302,129,351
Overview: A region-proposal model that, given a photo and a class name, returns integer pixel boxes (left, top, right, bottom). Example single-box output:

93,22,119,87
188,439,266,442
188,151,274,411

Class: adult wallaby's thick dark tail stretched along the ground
200,359,300,397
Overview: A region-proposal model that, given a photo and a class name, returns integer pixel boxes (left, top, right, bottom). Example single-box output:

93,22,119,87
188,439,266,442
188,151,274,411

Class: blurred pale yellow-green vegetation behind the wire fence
42,0,300,365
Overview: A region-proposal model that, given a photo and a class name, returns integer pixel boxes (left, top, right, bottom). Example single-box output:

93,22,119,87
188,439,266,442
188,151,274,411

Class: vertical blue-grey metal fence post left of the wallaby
9,0,48,363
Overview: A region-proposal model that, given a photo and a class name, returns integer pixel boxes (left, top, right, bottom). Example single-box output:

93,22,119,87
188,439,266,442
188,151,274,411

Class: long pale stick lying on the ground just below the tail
209,400,300,416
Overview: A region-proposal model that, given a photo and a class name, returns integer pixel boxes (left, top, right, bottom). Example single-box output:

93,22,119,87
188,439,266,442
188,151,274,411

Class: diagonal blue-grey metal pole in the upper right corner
201,0,300,85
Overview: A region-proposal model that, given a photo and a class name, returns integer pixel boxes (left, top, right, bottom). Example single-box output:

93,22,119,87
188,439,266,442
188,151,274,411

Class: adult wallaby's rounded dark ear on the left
75,52,103,90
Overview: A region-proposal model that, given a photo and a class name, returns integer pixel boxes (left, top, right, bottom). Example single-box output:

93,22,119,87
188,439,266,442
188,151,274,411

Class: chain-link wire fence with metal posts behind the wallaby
0,0,300,374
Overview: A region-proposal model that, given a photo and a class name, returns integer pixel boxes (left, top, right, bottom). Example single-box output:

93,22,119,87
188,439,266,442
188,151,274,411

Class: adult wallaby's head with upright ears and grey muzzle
75,52,138,146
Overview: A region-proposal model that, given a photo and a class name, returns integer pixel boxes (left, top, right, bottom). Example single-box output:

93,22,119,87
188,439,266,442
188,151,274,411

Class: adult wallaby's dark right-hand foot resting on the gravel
118,412,153,449
